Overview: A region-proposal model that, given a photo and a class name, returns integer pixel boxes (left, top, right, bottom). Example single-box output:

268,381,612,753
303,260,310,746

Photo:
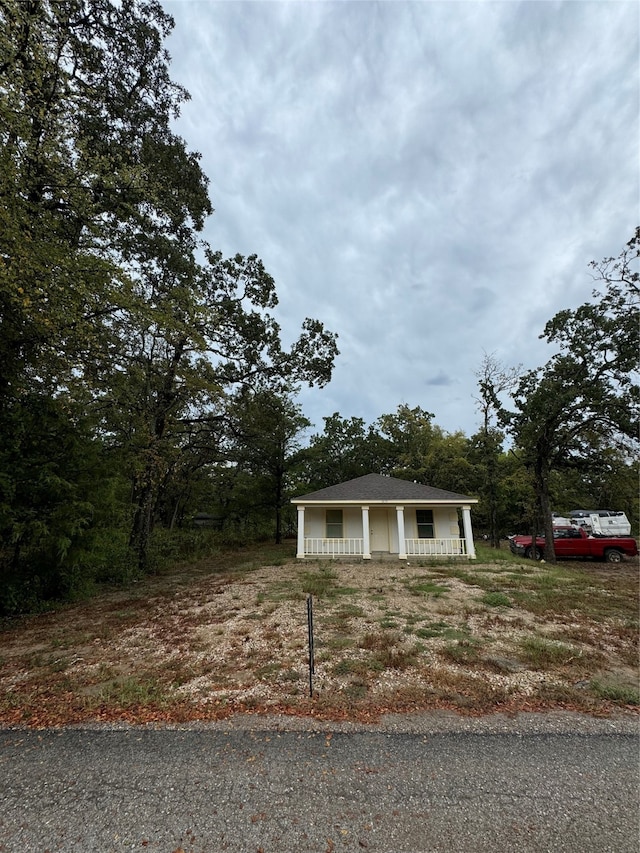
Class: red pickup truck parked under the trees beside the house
509,525,638,563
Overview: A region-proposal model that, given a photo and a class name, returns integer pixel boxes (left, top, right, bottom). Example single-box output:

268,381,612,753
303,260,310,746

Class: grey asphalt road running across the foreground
0,723,640,853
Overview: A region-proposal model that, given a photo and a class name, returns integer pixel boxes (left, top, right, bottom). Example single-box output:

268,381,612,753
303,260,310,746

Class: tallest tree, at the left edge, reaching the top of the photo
0,0,211,600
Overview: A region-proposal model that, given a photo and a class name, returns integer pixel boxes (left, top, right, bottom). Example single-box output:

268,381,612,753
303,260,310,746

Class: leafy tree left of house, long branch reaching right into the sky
94,241,337,568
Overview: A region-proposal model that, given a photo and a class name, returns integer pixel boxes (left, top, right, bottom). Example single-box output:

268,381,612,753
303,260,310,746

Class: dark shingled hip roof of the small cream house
291,474,478,504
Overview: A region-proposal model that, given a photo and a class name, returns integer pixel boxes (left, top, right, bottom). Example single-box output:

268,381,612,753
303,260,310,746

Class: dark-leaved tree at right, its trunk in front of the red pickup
505,229,640,561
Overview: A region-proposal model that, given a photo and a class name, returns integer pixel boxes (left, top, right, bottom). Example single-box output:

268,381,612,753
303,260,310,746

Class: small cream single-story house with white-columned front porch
291,474,478,560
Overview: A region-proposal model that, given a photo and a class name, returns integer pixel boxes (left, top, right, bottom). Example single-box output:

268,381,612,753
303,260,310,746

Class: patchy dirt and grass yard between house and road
0,553,640,726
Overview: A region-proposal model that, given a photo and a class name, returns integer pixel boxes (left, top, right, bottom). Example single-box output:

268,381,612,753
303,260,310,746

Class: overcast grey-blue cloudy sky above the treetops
163,0,640,435
